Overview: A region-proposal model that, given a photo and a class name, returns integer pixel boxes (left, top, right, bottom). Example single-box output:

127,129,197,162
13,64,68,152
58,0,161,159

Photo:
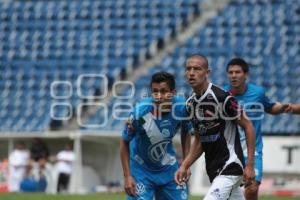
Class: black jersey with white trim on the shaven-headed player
186,83,244,182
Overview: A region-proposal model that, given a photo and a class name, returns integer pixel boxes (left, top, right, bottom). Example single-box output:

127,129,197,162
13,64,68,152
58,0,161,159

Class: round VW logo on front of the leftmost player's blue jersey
148,140,170,162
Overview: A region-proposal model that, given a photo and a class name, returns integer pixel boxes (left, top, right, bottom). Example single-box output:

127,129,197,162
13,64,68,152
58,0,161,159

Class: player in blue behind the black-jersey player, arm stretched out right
225,58,296,200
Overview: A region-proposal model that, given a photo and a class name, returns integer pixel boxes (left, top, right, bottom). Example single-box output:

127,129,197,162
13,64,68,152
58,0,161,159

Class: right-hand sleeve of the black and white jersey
223,96,242,118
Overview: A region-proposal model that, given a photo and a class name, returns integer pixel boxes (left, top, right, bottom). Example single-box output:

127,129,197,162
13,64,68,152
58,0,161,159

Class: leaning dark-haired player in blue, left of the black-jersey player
120,72,193,200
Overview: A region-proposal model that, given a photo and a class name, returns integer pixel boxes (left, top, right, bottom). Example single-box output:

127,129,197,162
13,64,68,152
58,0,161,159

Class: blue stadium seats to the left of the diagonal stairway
0,0,201,132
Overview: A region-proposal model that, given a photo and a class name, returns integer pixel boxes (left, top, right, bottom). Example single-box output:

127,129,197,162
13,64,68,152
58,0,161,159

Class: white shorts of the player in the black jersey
204,175,245,200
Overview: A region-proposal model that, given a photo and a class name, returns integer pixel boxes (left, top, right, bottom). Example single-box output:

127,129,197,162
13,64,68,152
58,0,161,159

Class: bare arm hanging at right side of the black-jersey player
237,113,255,185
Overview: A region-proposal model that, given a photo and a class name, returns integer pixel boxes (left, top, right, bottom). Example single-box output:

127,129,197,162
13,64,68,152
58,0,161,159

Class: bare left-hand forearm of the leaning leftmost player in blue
120,139,136,196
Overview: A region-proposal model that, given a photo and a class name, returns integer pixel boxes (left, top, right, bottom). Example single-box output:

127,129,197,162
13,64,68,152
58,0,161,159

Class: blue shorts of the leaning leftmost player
127,162,188,200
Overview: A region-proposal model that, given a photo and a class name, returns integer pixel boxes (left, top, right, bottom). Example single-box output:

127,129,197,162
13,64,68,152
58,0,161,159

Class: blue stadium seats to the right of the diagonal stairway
85,0,300,134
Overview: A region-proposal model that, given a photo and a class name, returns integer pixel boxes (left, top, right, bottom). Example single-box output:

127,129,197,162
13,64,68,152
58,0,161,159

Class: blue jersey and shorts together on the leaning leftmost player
122,97,192,200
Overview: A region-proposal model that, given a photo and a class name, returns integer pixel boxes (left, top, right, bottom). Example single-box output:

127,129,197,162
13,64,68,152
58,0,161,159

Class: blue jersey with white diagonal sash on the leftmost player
122,96,192,171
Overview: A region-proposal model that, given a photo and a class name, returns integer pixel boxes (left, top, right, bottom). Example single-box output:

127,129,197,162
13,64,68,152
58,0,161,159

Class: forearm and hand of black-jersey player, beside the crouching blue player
175,132,203,185
